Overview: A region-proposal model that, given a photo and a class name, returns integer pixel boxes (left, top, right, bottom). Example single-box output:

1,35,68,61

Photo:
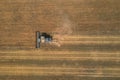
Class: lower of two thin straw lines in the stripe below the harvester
0,56,120,60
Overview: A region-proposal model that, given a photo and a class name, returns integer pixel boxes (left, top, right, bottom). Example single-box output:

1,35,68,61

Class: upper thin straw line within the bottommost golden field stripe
0,65,120,71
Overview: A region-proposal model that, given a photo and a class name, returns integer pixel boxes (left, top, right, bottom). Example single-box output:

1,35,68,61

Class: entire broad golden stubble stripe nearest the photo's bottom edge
0,66,120,77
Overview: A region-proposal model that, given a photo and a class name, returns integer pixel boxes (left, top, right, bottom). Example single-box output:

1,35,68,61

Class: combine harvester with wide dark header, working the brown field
36,31,53,48
